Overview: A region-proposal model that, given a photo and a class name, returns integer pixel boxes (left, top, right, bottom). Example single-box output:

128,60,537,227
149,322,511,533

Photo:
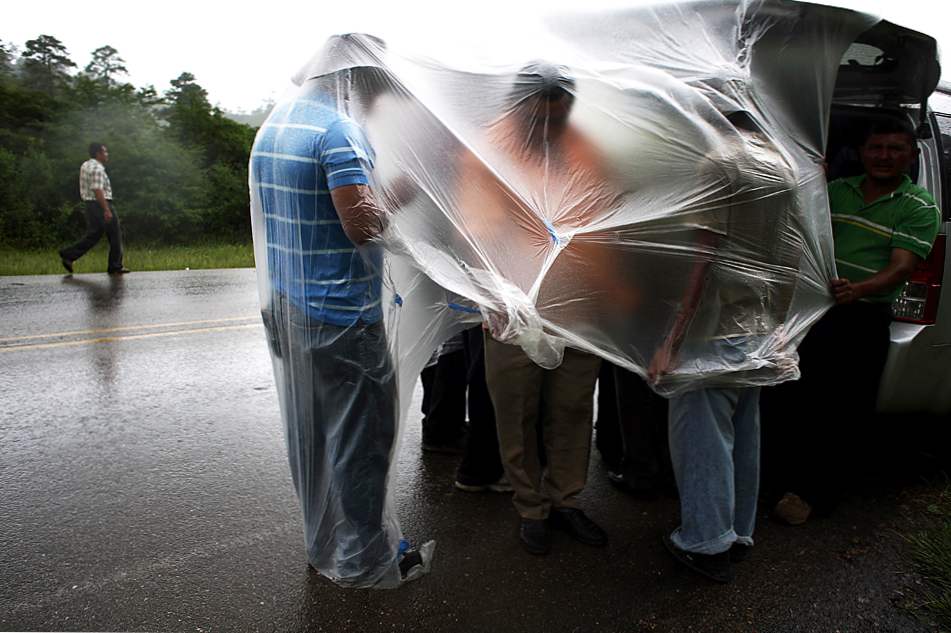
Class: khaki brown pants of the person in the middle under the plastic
485,335,601,519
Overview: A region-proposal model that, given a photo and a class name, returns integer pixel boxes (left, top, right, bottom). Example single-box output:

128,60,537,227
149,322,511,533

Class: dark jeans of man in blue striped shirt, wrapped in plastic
264,296,399,585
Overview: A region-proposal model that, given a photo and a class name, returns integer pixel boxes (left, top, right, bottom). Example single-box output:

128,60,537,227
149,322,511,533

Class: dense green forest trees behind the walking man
0,35,255,249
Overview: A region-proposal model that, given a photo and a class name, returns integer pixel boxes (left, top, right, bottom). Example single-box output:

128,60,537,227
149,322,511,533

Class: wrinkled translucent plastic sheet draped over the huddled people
251,2,875,586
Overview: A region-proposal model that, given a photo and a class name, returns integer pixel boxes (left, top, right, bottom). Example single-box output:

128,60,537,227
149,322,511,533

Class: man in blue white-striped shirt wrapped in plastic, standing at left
250,35,433,587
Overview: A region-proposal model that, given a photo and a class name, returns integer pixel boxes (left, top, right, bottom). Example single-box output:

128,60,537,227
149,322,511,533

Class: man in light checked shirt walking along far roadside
59,143,129,275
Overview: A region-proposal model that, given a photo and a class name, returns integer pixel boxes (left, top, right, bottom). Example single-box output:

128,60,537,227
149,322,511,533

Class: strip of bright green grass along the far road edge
0,240,254,276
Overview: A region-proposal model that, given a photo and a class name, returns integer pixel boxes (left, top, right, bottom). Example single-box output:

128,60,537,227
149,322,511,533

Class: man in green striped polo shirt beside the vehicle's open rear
764,120,941,524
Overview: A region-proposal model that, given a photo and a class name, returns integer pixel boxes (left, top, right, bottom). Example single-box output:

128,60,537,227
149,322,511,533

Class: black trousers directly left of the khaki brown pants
457,325,504,483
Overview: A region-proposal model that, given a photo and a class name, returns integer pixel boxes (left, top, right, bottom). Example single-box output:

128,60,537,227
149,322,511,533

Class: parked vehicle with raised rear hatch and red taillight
826,21,951,414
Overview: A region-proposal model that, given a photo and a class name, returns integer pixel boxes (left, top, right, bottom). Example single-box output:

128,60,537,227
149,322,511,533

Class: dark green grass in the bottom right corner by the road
905,488,951,631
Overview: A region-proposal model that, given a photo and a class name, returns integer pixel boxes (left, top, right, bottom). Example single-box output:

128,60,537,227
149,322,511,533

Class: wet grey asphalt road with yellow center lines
0,270,931,632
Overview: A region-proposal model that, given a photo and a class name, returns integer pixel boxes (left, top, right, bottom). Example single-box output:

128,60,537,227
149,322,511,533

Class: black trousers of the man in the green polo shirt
762,302,891,513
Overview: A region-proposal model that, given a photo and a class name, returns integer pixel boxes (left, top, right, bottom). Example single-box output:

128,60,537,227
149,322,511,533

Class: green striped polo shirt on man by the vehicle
829,174,941,303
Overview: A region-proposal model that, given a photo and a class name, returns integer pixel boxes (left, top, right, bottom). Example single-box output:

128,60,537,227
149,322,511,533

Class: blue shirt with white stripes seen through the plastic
251,99,383,326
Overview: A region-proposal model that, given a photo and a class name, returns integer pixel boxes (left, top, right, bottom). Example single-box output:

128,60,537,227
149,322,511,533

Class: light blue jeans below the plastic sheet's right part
669,387,760,554
